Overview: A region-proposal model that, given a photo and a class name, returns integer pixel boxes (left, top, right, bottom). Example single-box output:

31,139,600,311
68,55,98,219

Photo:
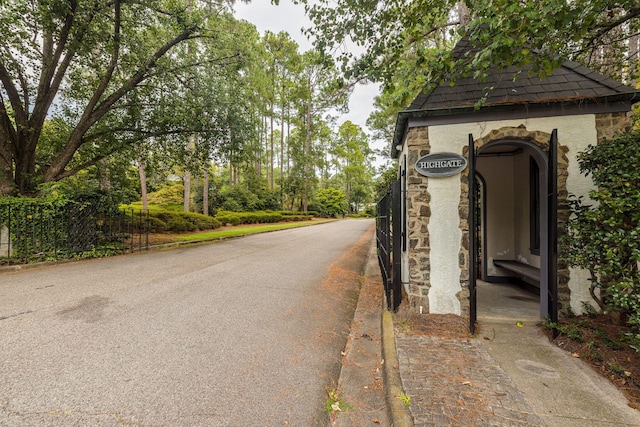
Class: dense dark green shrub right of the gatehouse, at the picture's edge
563,130,640,348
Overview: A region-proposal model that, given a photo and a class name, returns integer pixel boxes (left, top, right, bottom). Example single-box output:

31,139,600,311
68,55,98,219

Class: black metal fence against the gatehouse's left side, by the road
376,181,402,311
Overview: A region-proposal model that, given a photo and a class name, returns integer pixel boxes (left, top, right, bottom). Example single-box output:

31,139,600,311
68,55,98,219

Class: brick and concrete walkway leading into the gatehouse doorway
382,282,640,427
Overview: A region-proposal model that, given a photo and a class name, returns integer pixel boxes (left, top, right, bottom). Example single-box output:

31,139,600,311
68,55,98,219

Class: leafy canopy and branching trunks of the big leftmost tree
0,0,250,195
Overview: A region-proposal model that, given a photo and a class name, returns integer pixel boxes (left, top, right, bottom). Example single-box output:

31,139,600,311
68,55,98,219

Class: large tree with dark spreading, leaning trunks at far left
0,0,244,195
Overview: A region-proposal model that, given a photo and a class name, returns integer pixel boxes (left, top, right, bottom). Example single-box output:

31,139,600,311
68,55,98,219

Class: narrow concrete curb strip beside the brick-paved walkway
381,308,414,427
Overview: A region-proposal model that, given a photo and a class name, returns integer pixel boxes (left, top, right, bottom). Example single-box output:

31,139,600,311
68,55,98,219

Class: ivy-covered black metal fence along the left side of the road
0,201,149,265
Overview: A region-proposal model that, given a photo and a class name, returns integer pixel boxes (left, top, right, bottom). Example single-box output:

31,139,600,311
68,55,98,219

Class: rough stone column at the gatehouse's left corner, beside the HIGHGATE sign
406,127,431,311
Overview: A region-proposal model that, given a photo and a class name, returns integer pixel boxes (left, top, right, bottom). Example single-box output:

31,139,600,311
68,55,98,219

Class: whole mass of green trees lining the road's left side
0,0,380,217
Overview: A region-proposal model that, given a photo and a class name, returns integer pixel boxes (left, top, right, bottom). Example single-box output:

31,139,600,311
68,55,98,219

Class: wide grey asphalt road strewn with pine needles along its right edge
0,220,374,426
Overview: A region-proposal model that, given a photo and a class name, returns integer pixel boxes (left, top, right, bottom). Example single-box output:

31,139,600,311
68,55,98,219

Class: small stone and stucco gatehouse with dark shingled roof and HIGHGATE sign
392,43,640,330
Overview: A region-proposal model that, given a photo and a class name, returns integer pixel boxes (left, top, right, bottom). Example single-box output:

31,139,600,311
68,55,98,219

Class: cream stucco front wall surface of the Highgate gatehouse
429,115,597,314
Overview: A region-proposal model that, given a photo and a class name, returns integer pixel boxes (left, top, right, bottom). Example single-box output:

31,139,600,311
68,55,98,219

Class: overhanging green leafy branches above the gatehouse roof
300,0,640,107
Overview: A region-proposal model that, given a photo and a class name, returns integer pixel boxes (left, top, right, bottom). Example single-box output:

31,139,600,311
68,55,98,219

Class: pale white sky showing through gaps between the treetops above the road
234,0,379,144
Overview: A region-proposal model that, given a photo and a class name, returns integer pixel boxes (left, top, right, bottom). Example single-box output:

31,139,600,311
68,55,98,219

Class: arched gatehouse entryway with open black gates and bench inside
469,127,557,334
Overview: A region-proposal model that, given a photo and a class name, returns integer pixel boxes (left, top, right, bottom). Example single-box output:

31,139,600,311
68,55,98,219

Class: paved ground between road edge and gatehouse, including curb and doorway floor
332,239,640,427
